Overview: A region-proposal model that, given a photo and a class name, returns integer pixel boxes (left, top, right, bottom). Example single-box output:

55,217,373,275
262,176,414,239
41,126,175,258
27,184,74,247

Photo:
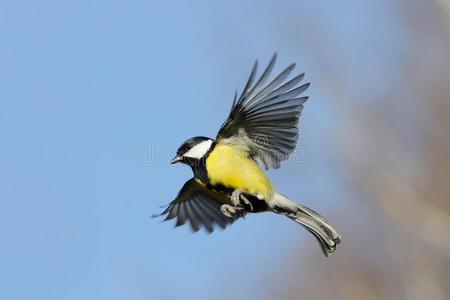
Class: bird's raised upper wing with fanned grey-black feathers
217,53,309,169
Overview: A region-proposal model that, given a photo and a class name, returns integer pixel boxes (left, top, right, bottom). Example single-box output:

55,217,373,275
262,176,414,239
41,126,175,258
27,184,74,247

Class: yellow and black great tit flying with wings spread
157,52,341,256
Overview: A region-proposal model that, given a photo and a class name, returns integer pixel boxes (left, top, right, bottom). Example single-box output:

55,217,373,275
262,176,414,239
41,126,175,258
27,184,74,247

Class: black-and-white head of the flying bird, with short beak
170,136,214,166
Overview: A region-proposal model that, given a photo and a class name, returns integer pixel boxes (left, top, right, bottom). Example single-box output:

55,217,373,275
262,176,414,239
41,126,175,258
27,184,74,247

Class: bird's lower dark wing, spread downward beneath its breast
156,178,236,232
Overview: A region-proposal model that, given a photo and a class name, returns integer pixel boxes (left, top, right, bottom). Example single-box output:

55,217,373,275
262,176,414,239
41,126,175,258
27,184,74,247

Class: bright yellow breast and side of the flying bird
206,144,273,199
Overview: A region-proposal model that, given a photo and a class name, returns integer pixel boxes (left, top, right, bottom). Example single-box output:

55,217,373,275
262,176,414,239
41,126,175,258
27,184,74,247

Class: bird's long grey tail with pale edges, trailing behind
270,193,341,256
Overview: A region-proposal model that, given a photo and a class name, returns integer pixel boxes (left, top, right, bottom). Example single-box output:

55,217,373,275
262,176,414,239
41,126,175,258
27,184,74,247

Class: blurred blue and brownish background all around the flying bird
0,0,450,299
